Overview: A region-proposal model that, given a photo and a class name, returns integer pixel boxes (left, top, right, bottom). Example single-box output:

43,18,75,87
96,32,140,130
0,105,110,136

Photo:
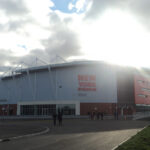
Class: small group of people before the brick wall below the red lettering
88,111,104,120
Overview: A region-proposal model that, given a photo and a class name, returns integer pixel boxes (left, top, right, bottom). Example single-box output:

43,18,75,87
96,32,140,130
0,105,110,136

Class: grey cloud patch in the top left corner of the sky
0,0,28,16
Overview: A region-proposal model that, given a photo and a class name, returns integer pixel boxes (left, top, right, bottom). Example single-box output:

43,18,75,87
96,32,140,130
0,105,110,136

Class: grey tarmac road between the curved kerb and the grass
0,119,149,150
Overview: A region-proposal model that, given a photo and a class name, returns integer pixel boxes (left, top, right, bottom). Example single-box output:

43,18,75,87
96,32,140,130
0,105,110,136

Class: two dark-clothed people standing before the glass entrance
53,110,63,126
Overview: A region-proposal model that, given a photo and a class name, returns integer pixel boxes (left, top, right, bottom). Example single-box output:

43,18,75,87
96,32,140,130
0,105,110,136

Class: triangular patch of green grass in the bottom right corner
116,126,150,150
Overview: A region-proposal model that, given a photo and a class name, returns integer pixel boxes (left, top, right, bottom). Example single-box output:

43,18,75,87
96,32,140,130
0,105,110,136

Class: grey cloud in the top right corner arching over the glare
85,0,150,27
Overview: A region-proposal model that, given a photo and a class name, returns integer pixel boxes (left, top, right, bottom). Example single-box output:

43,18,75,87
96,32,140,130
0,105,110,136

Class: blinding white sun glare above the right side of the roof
80,10,150,66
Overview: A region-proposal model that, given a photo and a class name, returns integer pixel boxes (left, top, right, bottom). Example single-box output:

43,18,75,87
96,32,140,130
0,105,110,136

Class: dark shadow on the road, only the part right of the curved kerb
51,119,149,134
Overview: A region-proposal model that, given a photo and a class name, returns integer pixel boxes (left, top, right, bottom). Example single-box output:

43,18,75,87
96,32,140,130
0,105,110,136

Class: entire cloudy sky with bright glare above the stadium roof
0,0,150,72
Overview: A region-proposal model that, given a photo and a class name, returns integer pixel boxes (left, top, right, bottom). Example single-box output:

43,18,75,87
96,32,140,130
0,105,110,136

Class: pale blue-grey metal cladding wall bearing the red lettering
0,63,117,104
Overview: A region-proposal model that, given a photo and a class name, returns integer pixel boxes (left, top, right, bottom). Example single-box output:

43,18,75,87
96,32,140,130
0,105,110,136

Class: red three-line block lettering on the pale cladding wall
78,75,96,91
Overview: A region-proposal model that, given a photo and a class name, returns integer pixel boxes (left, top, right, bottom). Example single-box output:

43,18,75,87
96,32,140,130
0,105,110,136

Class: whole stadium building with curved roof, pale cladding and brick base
0,61,150,116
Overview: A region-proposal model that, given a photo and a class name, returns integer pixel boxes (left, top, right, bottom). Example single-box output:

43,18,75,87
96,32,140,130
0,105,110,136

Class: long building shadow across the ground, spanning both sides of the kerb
0,119,149,139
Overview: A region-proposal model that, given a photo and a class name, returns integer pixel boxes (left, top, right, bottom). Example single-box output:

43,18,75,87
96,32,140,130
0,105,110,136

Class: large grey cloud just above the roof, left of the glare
21,28,81,65
